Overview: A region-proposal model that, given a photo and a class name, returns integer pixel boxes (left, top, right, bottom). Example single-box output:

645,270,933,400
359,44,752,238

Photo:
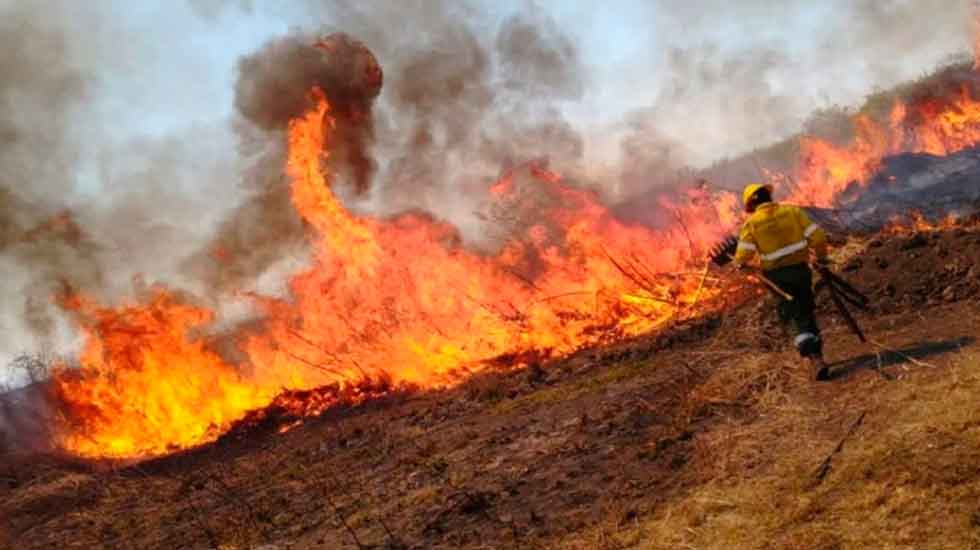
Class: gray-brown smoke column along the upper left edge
0,5,100,370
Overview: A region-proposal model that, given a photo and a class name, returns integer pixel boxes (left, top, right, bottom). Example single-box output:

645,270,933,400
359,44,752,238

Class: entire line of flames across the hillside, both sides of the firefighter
5,35,980,459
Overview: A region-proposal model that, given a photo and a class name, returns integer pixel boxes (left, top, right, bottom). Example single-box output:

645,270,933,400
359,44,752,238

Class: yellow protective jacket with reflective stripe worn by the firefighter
735,202,827,271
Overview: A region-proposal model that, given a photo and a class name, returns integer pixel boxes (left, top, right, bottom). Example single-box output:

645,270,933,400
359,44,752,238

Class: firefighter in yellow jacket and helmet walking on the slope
735,183,830,380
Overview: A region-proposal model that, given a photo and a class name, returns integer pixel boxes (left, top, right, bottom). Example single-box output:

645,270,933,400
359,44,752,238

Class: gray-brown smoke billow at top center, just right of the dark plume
378,7,585,222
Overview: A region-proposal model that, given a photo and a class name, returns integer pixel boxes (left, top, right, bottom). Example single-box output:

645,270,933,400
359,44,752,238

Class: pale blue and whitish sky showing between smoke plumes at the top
34,0,969,179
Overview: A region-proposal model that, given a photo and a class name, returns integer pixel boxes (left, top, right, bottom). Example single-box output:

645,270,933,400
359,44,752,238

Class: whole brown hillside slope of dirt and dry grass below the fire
0,222,980,549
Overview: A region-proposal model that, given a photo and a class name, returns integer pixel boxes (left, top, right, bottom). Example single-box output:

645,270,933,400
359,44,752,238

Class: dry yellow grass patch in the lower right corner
554,352,980,550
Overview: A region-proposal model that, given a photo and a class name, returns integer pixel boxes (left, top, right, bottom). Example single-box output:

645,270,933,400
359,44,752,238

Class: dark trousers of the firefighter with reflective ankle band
765,263,823,357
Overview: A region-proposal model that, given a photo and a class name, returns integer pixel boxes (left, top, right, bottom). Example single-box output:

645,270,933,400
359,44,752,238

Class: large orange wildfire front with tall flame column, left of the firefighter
47,91,736,458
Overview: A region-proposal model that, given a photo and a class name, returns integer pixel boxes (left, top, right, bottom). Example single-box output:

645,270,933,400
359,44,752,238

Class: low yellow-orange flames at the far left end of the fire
53,289,275,457
